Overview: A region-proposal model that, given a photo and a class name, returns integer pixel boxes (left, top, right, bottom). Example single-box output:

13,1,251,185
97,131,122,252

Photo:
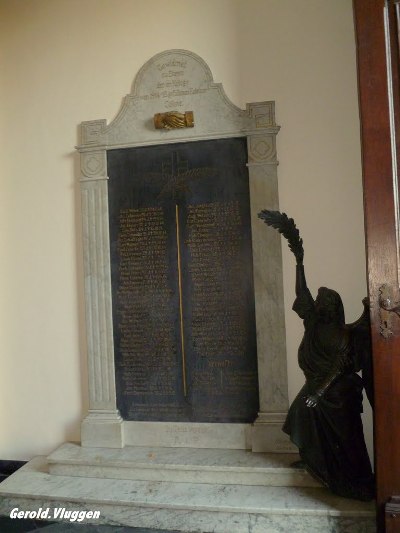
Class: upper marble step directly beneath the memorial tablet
47,443,320,487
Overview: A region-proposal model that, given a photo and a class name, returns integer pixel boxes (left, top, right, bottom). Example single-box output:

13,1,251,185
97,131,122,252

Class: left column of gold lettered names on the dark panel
117,207,176,397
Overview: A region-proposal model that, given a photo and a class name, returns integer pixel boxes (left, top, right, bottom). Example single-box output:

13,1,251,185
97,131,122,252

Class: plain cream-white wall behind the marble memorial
0,0,371,459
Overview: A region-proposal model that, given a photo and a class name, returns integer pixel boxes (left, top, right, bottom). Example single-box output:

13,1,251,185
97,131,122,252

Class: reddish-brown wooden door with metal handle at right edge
353,0,400,531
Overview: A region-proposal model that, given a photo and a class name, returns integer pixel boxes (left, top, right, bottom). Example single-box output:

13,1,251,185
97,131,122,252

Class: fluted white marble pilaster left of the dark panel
80,150,123,448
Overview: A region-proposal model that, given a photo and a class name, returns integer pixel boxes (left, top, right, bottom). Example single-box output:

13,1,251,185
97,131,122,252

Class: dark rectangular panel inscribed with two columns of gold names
108,139,258,422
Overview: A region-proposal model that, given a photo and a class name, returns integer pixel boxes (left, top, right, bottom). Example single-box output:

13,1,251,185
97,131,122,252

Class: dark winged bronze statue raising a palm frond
258,210,374,500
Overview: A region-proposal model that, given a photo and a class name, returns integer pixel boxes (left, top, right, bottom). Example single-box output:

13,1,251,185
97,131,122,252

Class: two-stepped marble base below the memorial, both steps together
0,445,376,533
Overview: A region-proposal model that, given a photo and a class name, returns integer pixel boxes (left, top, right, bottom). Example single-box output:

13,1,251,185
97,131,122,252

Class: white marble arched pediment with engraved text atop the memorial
79,50,279,151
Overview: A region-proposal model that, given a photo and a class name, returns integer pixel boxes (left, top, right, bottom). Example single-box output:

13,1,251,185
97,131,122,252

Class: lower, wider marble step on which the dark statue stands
0,458,376,533
